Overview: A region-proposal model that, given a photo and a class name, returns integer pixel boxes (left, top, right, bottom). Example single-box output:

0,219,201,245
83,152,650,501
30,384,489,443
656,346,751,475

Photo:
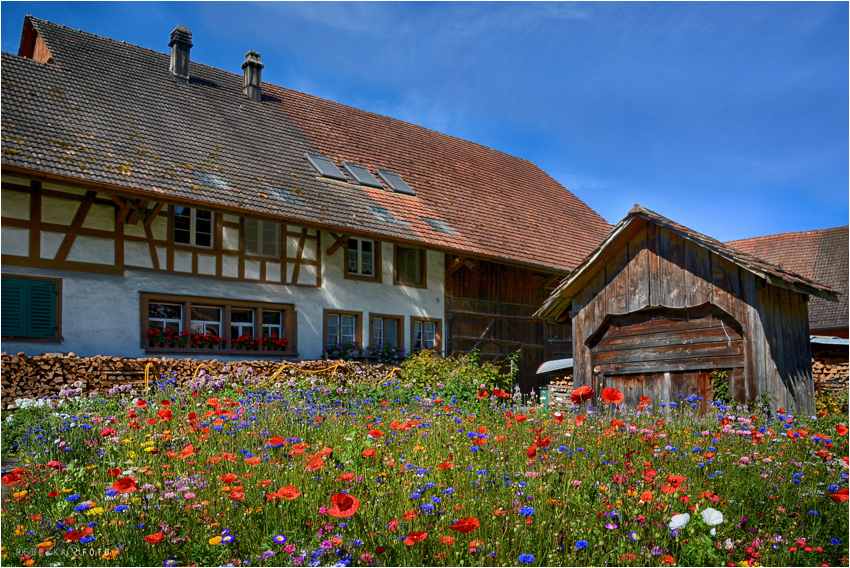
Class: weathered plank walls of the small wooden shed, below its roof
571,222,814,412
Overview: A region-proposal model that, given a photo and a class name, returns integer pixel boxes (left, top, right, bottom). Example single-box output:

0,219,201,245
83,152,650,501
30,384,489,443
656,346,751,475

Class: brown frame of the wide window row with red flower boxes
139,292,298,358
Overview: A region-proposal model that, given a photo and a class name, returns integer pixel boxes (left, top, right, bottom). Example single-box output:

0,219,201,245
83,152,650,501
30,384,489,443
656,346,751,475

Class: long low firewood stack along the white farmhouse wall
0,352,401,409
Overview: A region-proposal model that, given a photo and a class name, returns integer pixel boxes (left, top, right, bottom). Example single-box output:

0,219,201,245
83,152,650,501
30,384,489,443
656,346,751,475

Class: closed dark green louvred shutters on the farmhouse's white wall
0,278,56,339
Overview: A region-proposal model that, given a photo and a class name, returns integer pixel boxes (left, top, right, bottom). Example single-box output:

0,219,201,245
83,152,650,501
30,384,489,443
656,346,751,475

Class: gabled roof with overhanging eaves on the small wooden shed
534,205,837,320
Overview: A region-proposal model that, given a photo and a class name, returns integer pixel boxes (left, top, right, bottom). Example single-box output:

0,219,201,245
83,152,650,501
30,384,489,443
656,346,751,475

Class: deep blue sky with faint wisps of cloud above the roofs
2,1,850,240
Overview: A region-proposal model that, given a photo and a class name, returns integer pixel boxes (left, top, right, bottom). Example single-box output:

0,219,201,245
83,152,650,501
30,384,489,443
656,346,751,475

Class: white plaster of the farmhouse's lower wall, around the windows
2,227,445,360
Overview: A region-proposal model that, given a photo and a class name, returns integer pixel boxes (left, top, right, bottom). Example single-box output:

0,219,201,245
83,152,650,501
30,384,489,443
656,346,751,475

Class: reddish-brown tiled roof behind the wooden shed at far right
726,225,850,330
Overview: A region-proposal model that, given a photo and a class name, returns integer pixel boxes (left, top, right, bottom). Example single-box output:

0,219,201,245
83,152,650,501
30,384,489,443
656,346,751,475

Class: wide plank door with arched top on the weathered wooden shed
589,305,744,411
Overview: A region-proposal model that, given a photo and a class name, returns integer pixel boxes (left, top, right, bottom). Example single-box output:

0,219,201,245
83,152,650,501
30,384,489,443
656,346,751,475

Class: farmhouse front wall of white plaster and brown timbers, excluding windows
2,173,445,360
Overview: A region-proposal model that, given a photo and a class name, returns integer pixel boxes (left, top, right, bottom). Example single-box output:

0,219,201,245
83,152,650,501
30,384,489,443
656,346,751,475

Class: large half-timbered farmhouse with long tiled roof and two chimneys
2,17,610,384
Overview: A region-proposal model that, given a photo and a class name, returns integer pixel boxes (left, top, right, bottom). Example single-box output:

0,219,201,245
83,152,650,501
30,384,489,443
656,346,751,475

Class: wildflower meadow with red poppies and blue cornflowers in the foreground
2,352,848,566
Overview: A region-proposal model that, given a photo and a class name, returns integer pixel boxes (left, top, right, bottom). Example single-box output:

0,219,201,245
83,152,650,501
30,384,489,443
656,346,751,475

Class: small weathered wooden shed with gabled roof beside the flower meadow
535,205,837,413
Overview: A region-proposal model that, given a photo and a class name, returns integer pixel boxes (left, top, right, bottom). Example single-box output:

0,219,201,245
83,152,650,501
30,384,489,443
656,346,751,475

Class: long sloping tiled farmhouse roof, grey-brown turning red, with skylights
2,16,611,272
